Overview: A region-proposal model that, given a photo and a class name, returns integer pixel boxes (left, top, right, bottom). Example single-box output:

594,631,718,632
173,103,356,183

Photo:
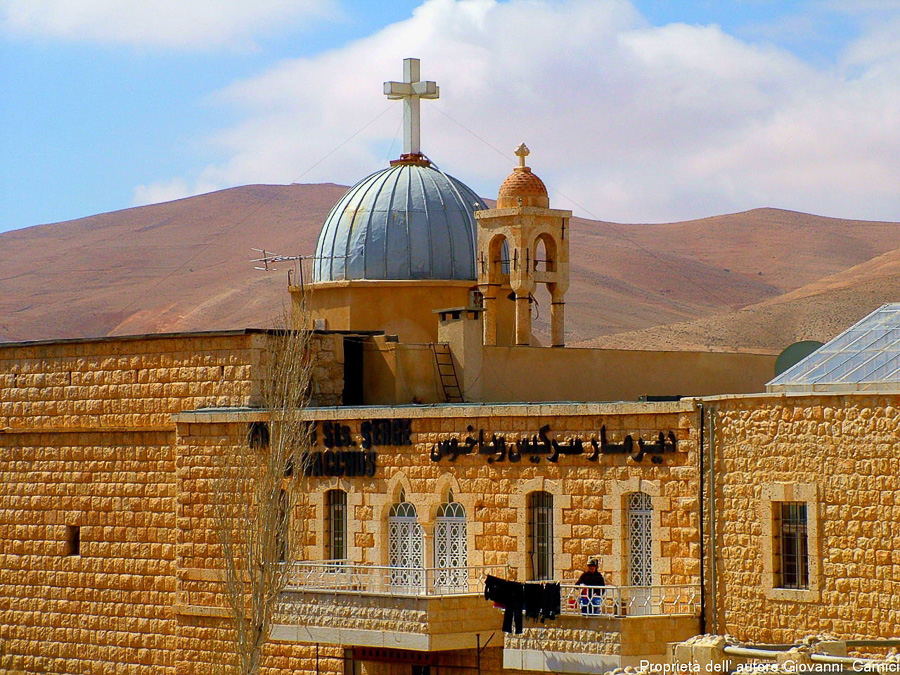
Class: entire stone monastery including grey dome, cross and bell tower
0,59,900,675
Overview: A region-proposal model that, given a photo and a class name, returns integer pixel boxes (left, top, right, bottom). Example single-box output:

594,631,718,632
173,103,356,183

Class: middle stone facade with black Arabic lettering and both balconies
176,402,700,673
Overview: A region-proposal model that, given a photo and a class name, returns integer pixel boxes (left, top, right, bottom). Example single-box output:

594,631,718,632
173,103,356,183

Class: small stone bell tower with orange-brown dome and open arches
475,143,572,347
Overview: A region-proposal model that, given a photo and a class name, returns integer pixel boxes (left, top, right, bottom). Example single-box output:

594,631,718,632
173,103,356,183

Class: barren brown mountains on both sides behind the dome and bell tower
0,184,900,349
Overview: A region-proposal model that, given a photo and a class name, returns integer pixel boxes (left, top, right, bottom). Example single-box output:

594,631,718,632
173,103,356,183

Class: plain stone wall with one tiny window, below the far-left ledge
0,430,176,673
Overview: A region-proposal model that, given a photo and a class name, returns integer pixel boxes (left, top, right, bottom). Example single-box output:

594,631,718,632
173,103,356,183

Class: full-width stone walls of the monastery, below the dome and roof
0,331,900,674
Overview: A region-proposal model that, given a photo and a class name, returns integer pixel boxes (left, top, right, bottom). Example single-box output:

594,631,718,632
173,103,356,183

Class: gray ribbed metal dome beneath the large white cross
313,160,488,282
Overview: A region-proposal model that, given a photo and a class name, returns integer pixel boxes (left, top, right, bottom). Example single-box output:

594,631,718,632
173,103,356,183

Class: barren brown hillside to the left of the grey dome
0,184,346,341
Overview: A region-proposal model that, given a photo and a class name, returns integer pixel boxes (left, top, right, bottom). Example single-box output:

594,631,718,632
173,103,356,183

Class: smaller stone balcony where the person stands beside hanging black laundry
503,582,700,673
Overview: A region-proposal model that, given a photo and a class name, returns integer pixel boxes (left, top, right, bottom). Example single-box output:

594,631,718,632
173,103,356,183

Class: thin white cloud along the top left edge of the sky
0,0,335,49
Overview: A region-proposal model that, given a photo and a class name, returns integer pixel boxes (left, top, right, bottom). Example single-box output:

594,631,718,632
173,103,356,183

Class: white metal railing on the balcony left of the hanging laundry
285,560,510,596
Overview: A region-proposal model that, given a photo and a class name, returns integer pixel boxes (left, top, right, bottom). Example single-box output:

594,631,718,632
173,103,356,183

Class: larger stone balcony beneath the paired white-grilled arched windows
272,561,510,651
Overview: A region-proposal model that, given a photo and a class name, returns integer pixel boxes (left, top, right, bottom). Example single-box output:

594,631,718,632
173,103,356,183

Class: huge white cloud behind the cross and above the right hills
134,0,900,222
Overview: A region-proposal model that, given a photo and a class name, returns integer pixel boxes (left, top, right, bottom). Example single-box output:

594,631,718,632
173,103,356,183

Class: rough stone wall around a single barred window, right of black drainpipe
708,394,900,643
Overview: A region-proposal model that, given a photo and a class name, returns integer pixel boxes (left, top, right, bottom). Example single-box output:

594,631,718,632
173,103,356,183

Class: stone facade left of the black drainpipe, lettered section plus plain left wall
0,331,712,673
